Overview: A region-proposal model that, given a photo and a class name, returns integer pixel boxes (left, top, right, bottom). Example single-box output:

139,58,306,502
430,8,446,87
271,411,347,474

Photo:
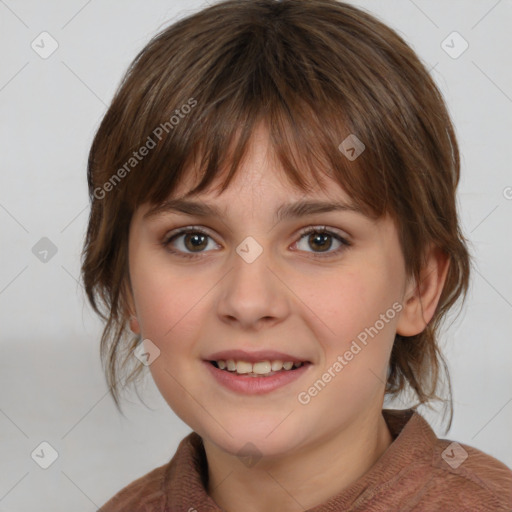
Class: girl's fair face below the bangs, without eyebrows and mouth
129,125,406,455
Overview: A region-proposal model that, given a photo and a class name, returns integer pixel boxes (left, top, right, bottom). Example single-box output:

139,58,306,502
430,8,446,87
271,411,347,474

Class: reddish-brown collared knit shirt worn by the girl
101,409,512,512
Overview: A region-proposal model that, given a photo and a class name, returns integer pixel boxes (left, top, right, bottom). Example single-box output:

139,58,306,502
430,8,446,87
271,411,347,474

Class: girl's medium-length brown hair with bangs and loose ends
82,0,470,423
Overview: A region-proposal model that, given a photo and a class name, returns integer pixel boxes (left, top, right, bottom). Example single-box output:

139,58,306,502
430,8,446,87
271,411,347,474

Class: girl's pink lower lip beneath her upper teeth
204,361,312,395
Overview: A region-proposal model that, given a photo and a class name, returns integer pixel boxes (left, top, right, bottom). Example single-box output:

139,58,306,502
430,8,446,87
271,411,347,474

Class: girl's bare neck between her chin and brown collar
203,409,393,512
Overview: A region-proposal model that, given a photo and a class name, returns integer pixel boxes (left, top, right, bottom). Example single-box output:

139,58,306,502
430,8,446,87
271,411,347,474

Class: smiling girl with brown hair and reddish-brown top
82,0,512,512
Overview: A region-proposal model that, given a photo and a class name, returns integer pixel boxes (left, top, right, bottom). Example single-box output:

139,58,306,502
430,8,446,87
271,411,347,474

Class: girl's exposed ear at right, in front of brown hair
396,246,450,336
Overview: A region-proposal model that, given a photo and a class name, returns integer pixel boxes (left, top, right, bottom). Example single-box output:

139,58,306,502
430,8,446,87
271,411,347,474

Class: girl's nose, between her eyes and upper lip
217,244,290,330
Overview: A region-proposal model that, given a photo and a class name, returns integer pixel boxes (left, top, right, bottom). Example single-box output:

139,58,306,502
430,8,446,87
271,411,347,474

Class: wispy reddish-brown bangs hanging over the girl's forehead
126,91,386,218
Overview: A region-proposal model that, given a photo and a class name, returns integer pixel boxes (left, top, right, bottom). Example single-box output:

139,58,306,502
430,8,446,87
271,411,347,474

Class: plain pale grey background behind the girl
0,0,512,512
